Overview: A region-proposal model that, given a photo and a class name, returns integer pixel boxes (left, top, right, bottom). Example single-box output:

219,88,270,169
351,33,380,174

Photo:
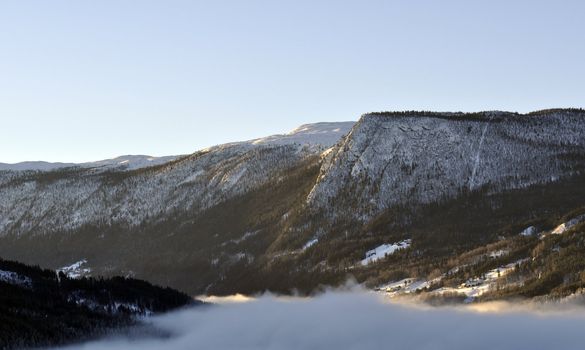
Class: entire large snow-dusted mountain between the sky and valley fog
0,109,585,298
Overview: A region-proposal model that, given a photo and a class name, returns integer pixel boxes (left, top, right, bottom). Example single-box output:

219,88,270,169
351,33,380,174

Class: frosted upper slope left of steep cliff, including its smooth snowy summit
0,123,353,235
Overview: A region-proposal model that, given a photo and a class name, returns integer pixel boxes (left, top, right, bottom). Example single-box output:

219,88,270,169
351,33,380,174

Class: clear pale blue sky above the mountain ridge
0,0,585,163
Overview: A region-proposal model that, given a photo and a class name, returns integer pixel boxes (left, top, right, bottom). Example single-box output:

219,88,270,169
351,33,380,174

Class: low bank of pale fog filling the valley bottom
59,292,585,350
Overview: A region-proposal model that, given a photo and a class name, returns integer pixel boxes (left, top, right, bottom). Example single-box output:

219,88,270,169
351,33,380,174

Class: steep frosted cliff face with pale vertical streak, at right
309,110,585,220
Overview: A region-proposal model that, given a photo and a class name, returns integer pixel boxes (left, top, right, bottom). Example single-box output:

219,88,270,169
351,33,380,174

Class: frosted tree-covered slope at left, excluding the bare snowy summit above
0,146,294,233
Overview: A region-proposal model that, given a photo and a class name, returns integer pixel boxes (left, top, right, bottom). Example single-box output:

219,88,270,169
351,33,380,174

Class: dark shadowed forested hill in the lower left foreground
0,260,199,349
